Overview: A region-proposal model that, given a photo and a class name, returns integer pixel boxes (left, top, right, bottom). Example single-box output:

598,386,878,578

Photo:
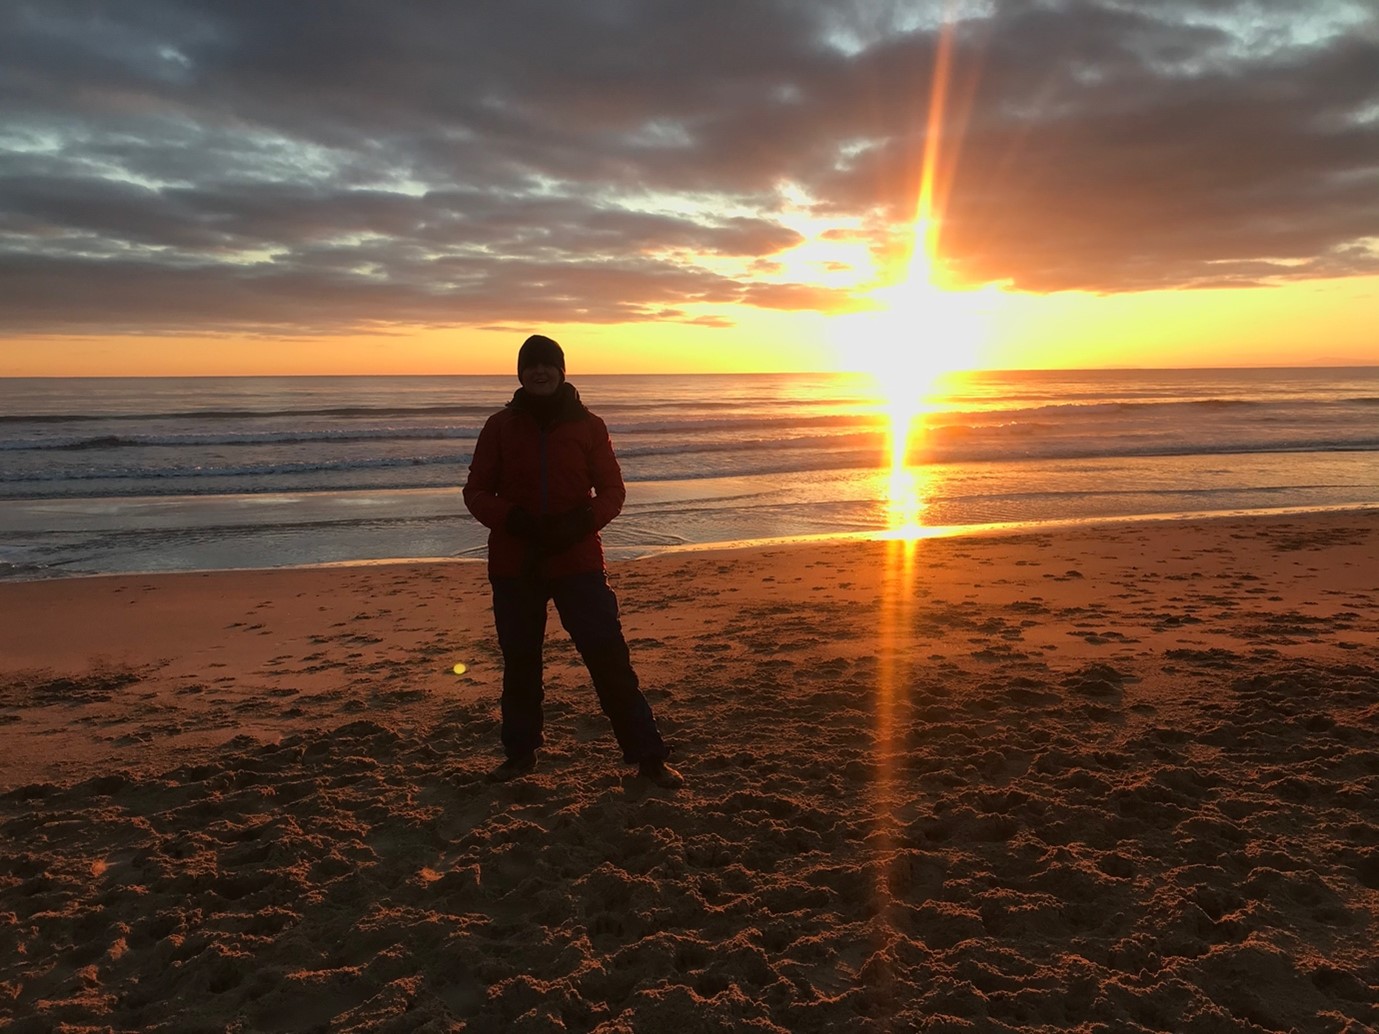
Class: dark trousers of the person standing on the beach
490,571,670,764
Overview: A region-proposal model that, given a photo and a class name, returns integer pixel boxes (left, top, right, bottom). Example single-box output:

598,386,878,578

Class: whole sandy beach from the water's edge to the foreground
0,511,1379,1033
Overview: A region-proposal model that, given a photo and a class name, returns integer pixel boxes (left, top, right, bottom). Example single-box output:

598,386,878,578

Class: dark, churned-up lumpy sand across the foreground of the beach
0,663,1379,1031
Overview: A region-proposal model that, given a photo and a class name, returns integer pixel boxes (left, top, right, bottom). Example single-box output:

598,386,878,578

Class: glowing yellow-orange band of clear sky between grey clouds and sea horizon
0,277,1379,376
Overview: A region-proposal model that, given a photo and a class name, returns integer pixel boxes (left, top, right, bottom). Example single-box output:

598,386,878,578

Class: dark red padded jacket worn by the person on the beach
465,383,627,578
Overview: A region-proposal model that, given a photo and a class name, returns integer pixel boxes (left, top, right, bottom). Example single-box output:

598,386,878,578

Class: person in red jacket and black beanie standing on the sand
463,334,684,787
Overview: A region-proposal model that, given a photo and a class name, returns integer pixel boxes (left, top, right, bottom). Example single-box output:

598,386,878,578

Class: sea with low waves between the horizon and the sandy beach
0,367,1379,579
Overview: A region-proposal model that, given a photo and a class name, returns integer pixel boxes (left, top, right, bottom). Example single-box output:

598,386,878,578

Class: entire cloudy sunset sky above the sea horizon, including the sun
0,0,1379,376
